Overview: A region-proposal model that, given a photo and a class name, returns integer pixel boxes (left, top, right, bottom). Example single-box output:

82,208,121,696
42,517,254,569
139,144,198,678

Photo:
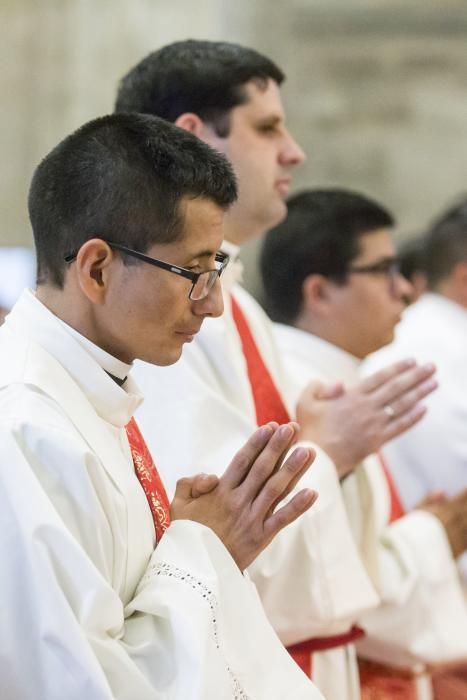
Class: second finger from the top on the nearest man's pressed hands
239,423,296,503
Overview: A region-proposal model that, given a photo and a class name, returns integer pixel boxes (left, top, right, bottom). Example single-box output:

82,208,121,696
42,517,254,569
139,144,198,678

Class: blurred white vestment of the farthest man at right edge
365,293,467,508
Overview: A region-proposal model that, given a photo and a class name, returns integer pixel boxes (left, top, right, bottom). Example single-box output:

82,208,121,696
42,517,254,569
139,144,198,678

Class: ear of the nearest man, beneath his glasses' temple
75,238,115,305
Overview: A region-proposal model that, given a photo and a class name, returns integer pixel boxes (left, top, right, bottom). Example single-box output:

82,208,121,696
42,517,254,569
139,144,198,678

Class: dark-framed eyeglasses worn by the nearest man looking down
65,239,229,301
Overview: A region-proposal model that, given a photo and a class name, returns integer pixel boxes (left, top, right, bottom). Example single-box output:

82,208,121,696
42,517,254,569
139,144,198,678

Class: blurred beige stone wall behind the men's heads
0,0,467,296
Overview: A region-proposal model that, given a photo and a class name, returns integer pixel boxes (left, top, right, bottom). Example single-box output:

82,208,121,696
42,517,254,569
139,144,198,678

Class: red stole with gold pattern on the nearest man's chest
126,418,170,542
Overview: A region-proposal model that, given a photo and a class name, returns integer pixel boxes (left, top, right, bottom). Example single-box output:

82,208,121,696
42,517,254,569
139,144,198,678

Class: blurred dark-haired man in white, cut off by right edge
369,197,467,532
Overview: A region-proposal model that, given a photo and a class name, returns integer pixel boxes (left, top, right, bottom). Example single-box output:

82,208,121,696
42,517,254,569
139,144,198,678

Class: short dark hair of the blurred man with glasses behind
260,189,394,325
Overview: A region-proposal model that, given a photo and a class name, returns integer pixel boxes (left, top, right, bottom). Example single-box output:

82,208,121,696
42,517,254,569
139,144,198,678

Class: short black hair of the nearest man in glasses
29,114,237,288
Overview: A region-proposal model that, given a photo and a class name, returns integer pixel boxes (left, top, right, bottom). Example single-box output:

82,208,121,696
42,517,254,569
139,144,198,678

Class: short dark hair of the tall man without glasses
115,39,284,136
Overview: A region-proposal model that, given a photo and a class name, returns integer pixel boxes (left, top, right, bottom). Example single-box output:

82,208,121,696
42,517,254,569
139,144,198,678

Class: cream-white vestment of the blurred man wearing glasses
275,324,467,666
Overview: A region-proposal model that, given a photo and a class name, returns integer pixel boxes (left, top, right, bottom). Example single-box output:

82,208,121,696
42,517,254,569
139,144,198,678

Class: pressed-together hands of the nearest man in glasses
171,423,317,571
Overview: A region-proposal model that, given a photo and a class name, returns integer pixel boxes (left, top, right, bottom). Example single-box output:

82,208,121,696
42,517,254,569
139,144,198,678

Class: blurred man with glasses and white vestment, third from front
261,189,467,698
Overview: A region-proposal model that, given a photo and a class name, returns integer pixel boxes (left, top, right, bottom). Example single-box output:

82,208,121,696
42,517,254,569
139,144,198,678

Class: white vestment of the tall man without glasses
135,250,378,700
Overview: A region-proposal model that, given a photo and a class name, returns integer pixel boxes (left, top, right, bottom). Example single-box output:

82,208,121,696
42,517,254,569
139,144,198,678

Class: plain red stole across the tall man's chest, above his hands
231,297,290,425
